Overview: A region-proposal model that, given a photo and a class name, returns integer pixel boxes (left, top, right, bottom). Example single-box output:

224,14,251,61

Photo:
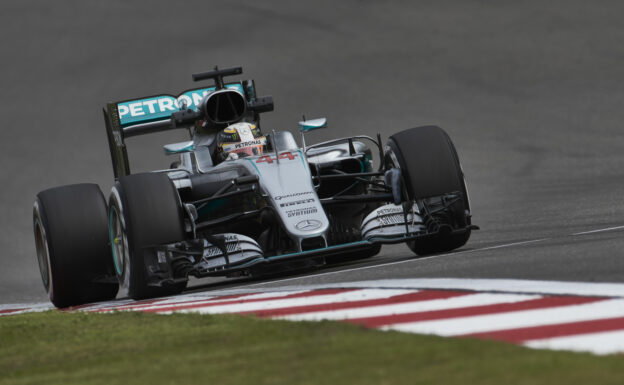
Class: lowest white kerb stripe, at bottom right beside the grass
523,330,624,354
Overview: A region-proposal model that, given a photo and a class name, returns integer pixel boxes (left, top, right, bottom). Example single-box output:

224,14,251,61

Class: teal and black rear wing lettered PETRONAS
103,77,273,179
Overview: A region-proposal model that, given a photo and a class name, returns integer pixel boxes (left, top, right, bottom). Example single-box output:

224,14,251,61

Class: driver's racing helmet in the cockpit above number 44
217,122,266,160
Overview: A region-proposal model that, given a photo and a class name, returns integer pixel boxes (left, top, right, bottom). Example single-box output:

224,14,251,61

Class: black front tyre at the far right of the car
385,126,470,255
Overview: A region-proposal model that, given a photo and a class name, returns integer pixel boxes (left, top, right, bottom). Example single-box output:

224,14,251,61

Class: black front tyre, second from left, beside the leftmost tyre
109,173,186,299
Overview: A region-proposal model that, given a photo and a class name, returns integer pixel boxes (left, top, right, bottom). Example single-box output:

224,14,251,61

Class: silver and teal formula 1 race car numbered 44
34,67,477,307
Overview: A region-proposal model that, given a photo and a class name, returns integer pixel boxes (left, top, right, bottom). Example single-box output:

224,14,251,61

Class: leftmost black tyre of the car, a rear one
33,184,119,307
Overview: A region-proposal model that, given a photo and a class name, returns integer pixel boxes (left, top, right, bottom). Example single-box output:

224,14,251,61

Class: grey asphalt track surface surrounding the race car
0,0,624,303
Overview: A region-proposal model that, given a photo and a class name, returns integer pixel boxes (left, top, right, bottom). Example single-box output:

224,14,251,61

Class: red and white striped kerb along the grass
0,278,624,355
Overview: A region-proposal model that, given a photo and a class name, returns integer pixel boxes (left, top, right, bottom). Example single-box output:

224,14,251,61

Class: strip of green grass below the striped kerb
0,311,624,385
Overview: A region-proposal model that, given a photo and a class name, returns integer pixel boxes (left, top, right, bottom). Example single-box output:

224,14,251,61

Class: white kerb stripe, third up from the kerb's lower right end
274,293,540,321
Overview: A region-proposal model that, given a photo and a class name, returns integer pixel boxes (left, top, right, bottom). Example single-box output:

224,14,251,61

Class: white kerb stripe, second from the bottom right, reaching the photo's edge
382,299,624,336
